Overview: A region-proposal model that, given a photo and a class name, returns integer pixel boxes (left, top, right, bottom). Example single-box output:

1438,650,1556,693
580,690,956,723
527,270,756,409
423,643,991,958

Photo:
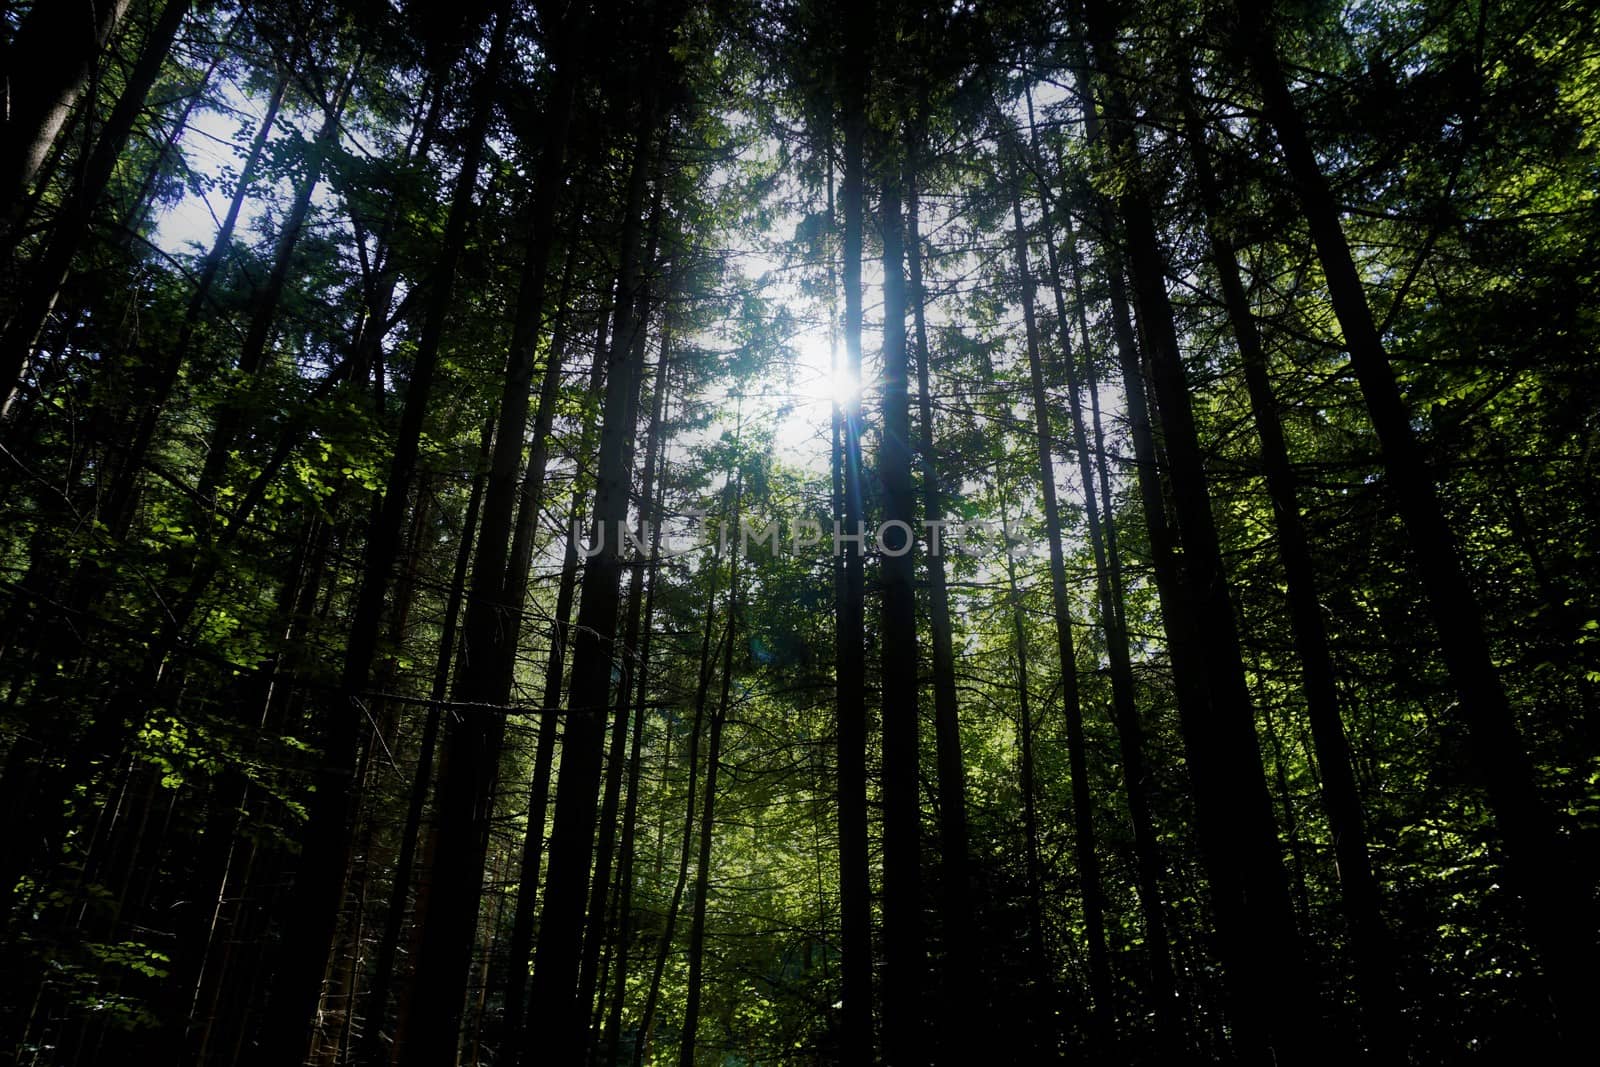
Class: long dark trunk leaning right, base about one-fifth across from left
256,10,509,1062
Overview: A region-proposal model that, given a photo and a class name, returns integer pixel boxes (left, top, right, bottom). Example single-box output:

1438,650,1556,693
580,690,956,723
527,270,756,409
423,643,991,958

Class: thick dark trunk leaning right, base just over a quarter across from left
400,6,587,1067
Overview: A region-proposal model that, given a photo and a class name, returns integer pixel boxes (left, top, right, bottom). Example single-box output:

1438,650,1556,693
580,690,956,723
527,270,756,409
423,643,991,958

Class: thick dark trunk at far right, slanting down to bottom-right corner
1237,0,1600,1056
